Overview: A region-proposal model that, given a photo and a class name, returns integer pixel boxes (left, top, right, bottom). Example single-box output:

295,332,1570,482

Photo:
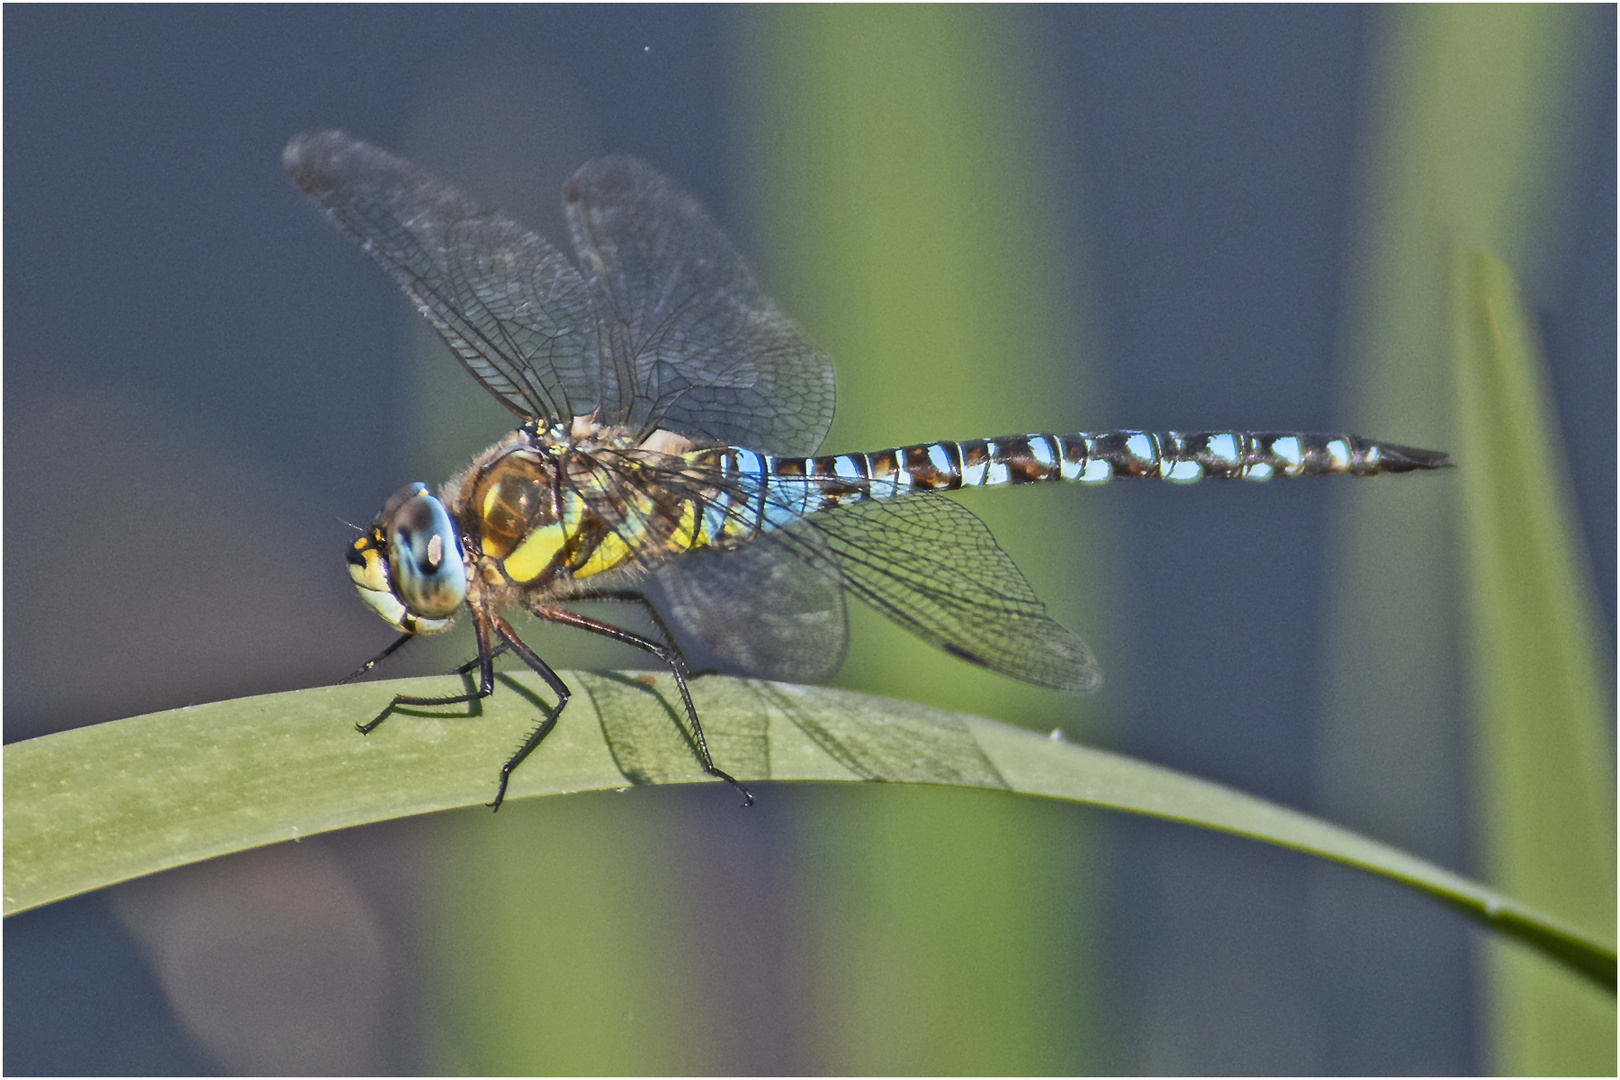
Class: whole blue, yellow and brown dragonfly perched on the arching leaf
284,131,1447,810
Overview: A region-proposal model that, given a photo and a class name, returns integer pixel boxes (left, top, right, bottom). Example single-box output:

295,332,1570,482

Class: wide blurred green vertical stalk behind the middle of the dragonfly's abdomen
735,6,1098,1074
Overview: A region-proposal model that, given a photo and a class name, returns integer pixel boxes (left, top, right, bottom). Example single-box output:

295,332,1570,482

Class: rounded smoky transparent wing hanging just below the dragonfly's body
653,529,849,682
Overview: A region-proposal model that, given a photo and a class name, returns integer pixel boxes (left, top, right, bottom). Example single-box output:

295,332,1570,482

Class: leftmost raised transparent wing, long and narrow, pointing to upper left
282,131,601,421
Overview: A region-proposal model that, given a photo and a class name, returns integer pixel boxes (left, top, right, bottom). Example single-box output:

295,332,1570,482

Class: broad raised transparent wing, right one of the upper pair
564,157,833,457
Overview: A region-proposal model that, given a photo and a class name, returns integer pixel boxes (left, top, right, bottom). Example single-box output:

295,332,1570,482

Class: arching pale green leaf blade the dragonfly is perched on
5,674,1615,989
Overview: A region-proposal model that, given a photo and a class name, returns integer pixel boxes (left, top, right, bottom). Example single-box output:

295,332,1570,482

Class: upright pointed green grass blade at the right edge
1455,253,1615,1074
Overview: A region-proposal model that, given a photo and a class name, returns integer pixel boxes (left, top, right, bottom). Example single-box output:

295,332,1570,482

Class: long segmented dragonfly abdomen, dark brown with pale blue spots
692,431,1447,542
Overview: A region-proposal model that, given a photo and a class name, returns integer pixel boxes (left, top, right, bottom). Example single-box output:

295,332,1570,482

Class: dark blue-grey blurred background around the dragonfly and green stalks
3,6,1615,1074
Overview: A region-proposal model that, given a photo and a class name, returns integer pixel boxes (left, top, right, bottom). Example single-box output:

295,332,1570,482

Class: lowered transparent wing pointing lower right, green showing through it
807,494,1102,691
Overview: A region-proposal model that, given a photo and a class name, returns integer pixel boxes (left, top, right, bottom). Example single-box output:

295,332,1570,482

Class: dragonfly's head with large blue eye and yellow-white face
347,484,467,633
